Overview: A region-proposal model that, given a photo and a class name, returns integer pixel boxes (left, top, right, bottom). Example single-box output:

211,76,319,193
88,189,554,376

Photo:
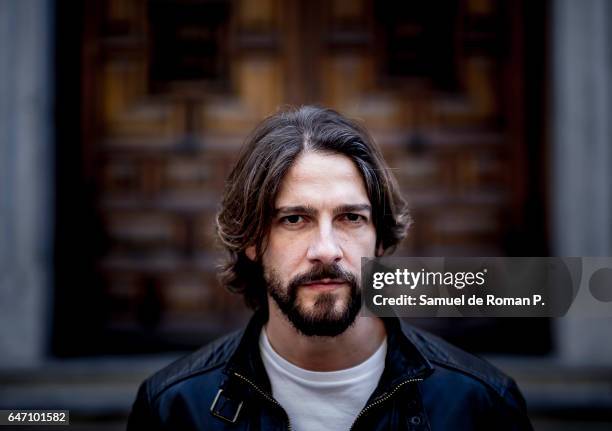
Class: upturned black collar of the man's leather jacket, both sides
224,310,433,394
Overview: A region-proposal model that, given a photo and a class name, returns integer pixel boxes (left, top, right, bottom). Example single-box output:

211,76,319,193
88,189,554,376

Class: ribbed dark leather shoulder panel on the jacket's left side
142,330,243,402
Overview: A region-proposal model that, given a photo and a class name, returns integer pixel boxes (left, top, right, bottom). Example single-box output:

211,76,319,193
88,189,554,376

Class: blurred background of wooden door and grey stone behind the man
0,0,612,430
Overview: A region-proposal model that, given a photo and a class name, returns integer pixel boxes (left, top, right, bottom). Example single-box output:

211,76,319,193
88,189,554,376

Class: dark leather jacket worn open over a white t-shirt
128,313,532,431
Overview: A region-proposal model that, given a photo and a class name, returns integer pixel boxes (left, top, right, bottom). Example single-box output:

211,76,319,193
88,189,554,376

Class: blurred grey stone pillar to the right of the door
550,0,612,365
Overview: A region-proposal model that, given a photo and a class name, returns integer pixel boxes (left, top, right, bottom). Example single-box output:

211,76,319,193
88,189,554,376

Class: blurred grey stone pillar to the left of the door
0,0,53,367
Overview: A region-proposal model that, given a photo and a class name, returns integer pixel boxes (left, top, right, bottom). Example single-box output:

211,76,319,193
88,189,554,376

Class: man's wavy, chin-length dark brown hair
217,106,410,308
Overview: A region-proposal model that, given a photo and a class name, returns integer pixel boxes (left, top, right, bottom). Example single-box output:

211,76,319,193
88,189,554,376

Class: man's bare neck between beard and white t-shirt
265,301,386,371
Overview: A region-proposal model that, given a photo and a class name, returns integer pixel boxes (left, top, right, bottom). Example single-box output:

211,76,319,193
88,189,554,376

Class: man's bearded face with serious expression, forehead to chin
255,152,376,336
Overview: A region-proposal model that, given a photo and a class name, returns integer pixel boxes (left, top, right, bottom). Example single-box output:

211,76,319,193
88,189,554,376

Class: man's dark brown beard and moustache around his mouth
264,263,361,337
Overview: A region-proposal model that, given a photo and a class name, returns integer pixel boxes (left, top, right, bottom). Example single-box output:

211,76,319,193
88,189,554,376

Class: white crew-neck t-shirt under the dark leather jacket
259,329,387,431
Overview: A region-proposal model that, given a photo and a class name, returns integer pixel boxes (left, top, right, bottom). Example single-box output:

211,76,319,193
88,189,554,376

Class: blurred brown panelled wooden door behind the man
56,0,545,353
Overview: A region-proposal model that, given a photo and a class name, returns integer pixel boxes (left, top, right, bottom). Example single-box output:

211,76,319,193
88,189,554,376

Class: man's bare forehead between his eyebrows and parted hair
275,151,370,208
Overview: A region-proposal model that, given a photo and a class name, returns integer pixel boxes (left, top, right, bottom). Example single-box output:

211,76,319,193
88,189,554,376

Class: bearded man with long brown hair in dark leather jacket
128,106,531,431
